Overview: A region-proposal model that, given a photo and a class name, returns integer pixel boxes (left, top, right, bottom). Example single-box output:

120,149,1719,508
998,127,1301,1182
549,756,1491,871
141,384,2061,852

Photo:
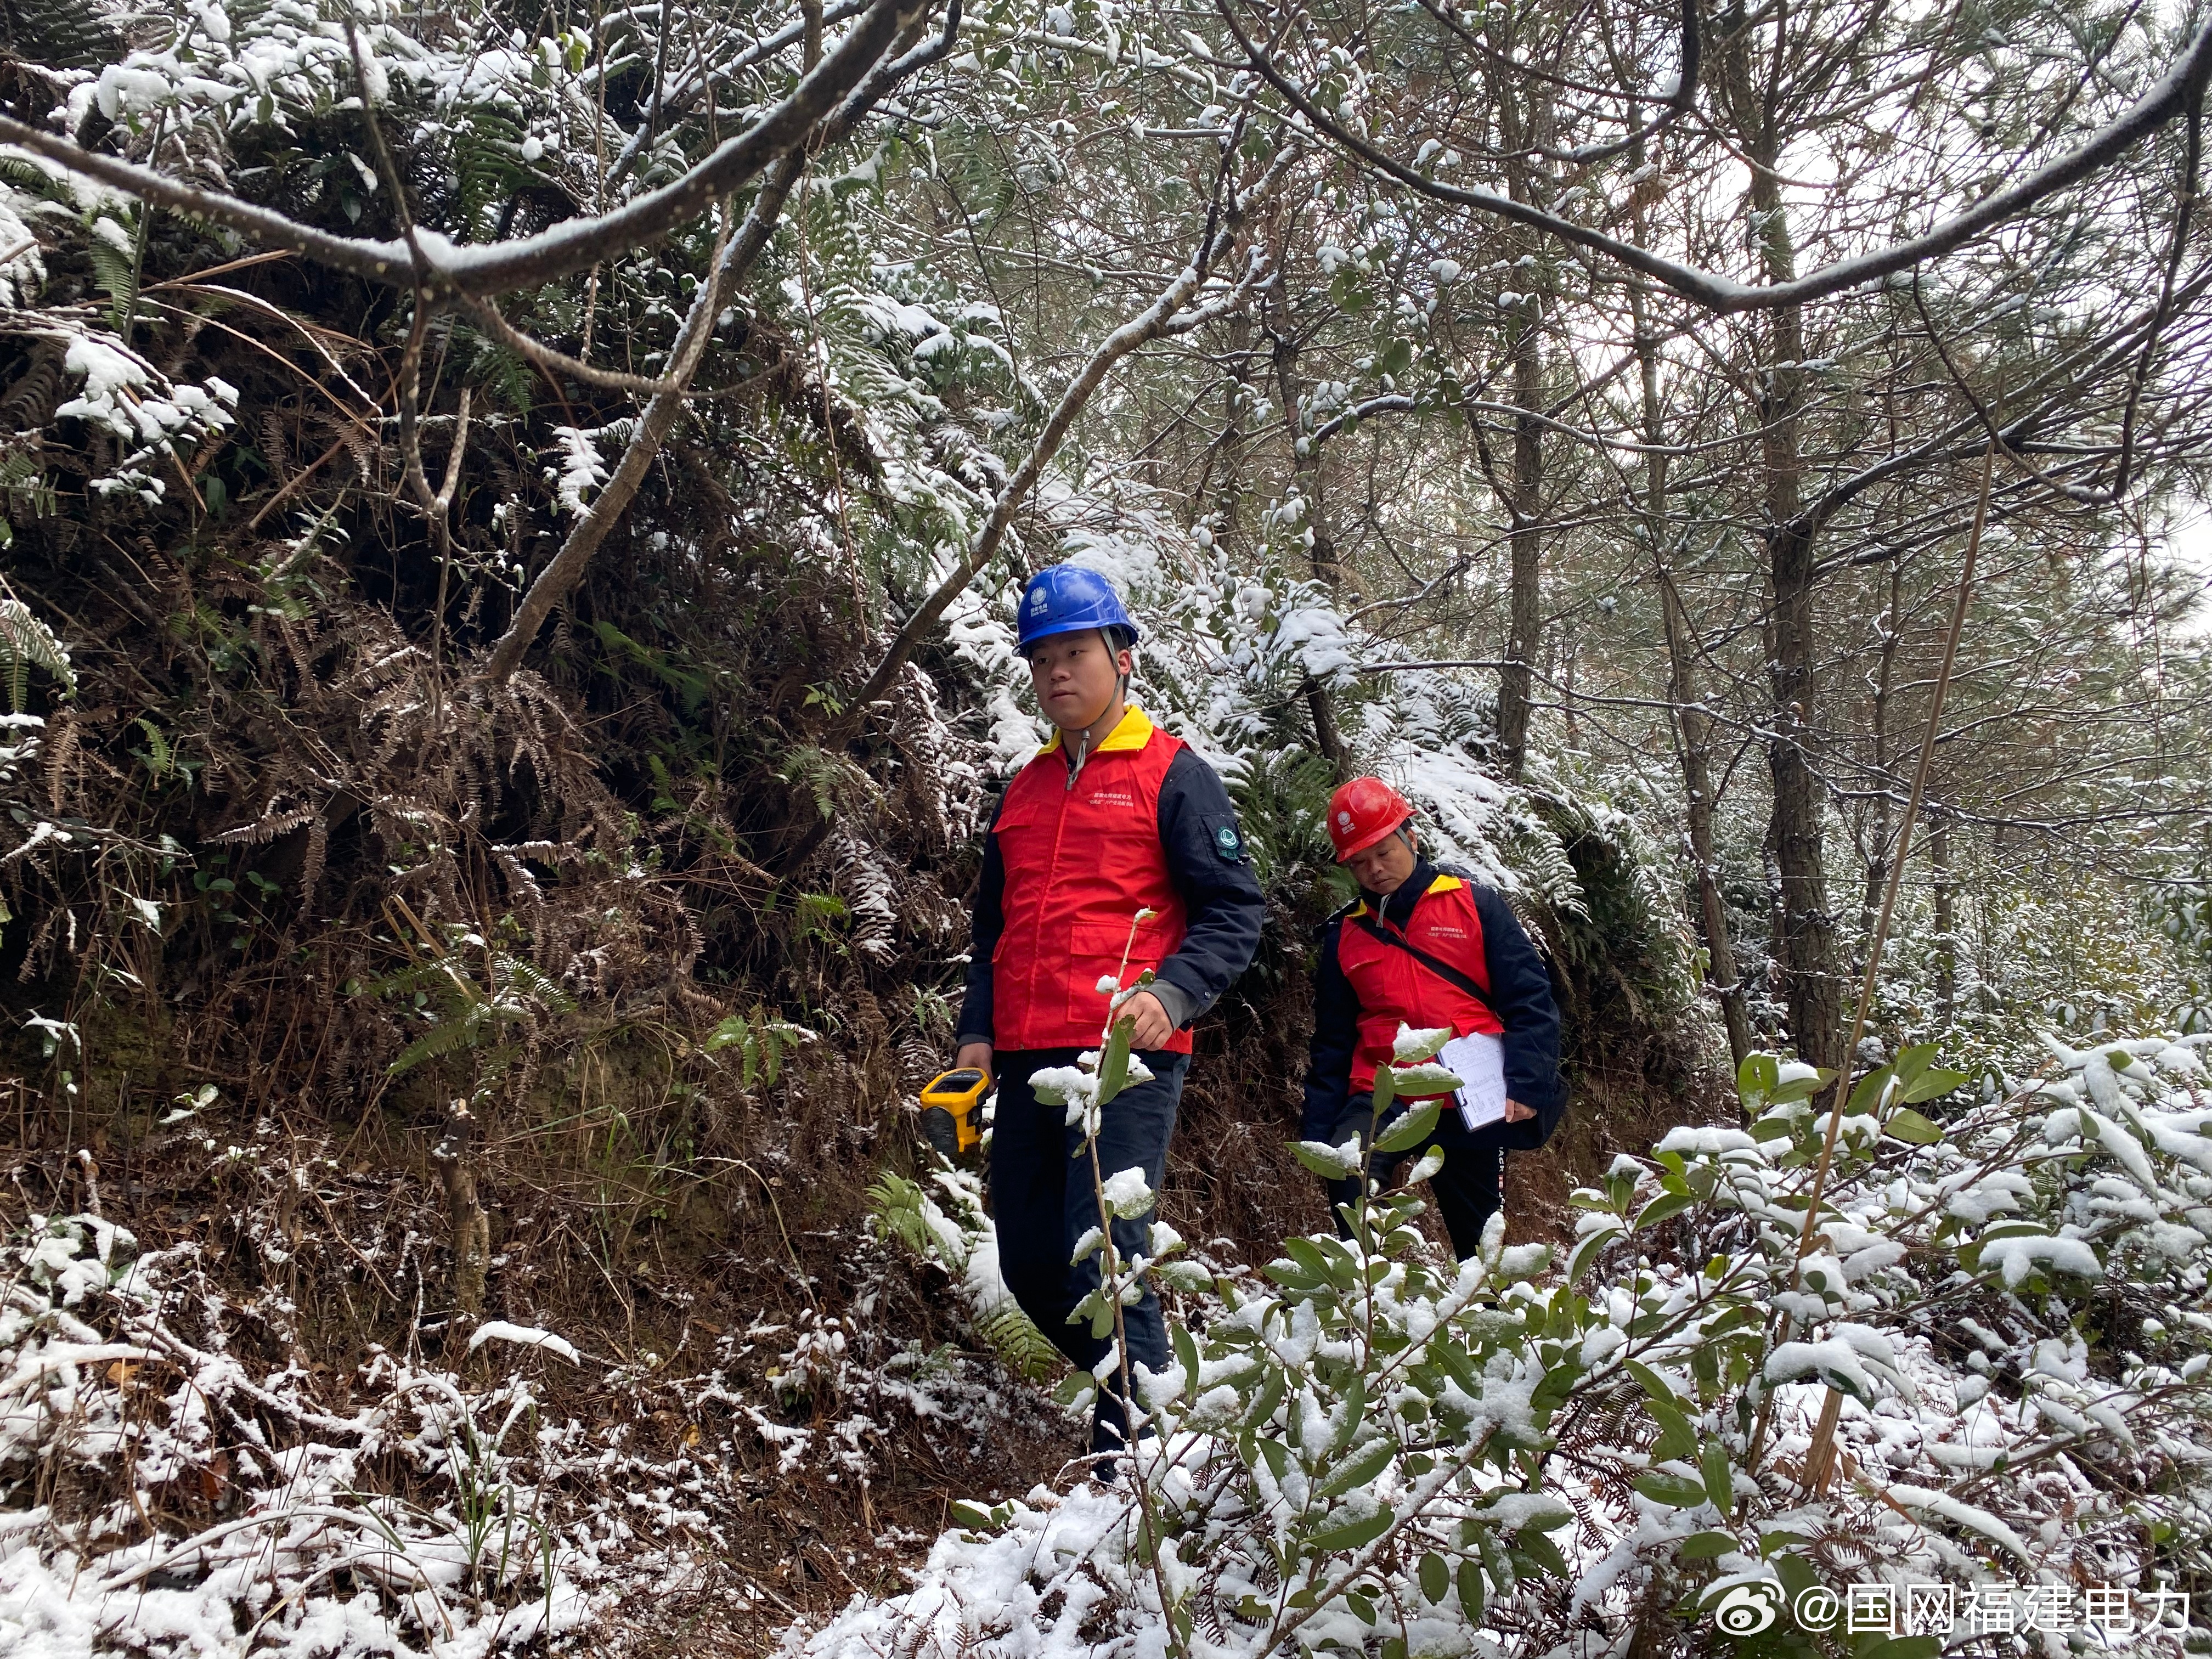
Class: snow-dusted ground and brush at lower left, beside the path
0,1177,1053,1659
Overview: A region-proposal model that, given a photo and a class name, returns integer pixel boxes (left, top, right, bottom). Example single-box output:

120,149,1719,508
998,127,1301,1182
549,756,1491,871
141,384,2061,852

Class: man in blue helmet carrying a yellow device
953,564,1265,1477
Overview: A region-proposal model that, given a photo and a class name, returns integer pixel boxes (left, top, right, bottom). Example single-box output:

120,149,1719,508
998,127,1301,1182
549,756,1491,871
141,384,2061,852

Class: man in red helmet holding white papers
1299,778,1566,1259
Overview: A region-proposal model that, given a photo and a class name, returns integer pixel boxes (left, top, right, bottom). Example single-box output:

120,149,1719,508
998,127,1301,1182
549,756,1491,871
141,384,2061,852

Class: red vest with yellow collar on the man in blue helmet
991,708,1190,1055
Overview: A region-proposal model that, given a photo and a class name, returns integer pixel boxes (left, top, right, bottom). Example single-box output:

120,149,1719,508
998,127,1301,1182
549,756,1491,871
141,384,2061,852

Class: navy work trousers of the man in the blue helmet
991,1048,1190,1451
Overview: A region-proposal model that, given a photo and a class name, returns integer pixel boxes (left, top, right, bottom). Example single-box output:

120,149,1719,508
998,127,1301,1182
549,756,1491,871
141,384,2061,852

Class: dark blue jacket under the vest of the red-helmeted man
1299,858,1566,1148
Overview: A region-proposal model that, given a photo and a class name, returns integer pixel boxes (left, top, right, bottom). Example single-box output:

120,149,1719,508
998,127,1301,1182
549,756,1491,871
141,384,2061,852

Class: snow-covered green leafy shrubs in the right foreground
792,1033,2212,1659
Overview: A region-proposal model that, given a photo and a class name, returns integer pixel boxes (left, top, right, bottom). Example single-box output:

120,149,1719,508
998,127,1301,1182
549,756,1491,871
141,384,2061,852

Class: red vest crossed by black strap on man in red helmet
1336,876,1504,1095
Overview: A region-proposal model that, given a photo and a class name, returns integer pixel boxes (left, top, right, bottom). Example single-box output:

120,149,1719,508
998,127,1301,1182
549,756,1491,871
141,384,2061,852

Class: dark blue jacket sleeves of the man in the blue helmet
956,748,1267,1044
